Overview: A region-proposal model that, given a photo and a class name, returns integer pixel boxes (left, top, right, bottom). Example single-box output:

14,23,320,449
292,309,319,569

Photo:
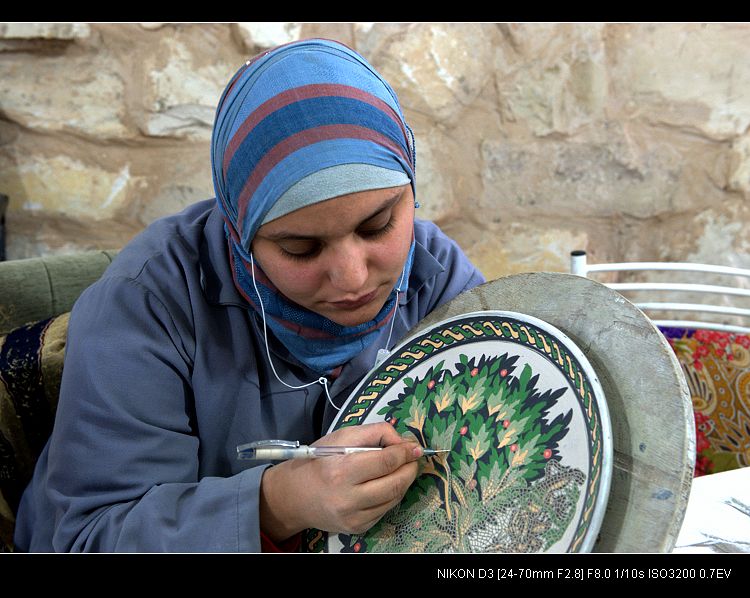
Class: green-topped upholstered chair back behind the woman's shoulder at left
0,251,117,552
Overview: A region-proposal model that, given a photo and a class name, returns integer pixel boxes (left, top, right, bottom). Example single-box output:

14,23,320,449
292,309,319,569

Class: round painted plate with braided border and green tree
305,311,612,553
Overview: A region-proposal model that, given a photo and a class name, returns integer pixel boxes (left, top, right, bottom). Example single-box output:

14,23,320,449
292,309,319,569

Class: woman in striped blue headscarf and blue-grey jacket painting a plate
15,40,483,552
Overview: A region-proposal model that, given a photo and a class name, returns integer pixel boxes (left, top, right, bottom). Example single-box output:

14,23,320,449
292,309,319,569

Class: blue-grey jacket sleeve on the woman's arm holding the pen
47,277,264,552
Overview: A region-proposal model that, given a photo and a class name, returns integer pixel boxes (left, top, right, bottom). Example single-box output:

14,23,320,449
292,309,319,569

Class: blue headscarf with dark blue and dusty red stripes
211,39,416,373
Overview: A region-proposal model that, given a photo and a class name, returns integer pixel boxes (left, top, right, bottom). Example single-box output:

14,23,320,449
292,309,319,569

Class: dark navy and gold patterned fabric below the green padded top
0,313,70,552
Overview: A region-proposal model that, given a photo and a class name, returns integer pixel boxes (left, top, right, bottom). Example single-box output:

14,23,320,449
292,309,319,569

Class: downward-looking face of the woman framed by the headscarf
252,185,414,326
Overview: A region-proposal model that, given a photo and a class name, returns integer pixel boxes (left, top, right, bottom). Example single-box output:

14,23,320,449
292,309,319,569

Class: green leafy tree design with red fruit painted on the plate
338,353,585,553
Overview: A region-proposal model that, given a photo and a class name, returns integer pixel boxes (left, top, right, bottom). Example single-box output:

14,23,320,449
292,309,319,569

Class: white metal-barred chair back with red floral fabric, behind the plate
570,251,750,476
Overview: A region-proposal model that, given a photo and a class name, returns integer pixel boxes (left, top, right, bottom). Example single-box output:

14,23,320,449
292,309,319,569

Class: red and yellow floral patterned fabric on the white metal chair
662,328,750,476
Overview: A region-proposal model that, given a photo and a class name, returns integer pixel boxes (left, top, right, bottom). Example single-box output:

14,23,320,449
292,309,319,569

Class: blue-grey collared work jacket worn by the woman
15,200,484,552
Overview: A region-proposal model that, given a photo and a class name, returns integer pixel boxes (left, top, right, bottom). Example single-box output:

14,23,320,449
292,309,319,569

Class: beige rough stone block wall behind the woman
0,23,750,278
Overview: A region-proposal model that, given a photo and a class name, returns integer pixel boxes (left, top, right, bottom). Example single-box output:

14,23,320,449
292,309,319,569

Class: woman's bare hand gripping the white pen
260,423,422,542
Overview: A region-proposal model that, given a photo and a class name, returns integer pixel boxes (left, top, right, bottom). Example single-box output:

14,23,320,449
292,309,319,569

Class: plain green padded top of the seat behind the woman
0,251,116,334
